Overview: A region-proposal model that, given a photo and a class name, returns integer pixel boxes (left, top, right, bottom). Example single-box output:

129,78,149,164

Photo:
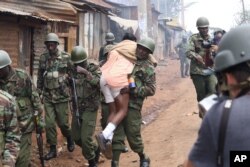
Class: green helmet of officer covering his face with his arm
71,46,88,64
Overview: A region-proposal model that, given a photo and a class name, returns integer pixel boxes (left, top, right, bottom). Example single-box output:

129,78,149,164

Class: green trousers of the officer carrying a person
112,108,144,161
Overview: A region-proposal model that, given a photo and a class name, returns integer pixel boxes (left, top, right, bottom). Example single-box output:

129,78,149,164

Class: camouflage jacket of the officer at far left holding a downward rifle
0,68,43,133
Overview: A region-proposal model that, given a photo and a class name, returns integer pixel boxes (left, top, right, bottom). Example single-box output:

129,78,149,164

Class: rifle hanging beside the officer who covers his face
71,77,80,127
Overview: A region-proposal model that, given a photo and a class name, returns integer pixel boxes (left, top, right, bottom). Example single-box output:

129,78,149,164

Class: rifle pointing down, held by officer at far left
34,111,45,167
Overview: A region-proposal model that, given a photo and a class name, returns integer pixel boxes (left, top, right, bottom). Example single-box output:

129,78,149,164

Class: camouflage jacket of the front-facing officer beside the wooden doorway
37,51,70,103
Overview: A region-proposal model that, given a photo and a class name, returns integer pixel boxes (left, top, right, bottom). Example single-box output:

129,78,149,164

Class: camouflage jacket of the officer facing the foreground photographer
186,33,212,75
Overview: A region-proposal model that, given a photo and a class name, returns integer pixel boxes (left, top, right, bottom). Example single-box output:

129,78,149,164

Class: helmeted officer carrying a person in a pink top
111,38,156,167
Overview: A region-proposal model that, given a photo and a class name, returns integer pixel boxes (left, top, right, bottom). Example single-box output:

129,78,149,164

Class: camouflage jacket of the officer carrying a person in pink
129,60,156,110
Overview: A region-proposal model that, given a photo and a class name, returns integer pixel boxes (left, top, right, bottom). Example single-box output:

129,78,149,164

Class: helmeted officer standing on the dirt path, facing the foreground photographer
186,17,217,117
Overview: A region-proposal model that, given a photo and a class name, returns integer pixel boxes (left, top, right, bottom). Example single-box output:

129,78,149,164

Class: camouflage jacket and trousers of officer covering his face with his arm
69,63,101,160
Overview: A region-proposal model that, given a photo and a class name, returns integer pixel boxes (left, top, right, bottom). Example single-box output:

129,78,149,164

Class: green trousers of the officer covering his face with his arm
71,109,98,160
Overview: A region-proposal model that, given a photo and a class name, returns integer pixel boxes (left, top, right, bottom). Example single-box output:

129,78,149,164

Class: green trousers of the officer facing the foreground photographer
191,74,217,101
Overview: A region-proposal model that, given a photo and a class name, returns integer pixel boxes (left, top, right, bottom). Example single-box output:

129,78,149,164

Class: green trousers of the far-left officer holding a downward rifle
15,133,32,167
